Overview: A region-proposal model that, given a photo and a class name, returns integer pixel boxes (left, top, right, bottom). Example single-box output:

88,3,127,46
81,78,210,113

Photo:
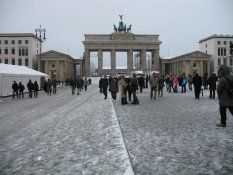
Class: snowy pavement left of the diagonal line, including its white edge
0,85,133,175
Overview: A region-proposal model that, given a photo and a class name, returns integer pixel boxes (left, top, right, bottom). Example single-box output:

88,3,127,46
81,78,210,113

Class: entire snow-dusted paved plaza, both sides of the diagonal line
0,81,233,175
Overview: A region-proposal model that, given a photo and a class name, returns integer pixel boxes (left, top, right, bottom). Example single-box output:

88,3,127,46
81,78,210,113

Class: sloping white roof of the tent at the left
0,63,48,77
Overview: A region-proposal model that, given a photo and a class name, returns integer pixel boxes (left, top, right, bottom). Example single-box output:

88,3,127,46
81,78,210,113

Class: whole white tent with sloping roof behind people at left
0,63,49,97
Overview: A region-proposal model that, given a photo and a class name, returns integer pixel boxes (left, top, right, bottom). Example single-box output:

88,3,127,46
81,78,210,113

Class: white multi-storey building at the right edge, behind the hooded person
199,35,233,73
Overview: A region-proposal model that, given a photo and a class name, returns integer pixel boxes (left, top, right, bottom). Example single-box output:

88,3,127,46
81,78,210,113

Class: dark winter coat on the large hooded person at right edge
217,75,233,106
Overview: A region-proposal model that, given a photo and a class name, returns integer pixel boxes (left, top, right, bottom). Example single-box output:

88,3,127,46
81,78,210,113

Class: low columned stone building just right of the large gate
162,51,211,76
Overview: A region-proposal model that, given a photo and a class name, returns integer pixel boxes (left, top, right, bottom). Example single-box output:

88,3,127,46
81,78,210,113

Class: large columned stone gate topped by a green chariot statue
83,15,161,76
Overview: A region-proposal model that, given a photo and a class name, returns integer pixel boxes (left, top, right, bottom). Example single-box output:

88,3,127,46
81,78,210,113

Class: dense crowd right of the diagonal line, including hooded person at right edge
99,66,233,127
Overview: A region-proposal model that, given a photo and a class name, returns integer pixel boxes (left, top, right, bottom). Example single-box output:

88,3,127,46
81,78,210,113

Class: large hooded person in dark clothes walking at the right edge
217,65,233,127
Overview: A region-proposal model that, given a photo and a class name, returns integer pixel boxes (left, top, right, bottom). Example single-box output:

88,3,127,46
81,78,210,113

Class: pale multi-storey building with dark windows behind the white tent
0,33,41,70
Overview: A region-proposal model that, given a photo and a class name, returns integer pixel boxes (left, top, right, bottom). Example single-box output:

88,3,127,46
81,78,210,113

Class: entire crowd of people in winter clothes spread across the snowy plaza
9,66,233,127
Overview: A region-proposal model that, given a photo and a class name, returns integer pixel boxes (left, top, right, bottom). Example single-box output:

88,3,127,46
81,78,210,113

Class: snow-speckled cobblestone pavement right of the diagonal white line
114,89,233,175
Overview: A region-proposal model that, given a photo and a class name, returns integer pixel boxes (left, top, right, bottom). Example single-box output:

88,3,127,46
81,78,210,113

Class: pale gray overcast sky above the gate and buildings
0,0,233,57
